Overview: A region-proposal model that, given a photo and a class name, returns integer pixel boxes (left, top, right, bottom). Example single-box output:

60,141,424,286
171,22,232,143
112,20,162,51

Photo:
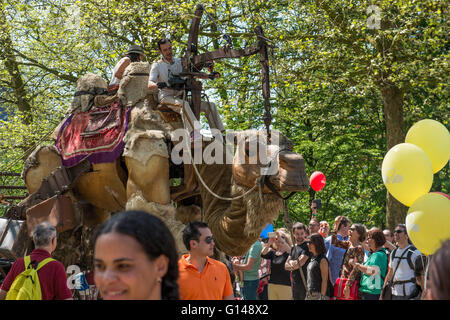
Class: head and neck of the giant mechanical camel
198,130,309,256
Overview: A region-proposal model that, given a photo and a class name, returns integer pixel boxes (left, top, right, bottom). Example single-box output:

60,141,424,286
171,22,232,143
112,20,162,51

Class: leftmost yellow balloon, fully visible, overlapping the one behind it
381,143,433,207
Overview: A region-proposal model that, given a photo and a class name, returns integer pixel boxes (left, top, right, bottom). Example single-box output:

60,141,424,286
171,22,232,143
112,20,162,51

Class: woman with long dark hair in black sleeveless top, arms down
306,233,332,300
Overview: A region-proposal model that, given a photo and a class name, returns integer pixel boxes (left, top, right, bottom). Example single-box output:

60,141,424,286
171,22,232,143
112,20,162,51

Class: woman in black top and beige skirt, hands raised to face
261,228,292,300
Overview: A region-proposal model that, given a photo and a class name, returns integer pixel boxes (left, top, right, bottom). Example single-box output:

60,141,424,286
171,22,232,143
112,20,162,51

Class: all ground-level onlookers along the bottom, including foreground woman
0,206,450,300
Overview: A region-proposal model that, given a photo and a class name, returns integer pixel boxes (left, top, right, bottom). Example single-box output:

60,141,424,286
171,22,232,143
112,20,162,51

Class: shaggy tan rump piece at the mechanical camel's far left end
22,146,62,194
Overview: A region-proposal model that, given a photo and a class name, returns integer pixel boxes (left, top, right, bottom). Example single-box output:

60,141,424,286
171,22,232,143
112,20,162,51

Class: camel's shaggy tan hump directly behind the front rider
118,62,150,106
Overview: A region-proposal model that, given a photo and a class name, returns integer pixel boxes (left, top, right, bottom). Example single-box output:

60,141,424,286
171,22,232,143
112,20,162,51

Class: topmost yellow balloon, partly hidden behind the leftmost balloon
405,119,450,173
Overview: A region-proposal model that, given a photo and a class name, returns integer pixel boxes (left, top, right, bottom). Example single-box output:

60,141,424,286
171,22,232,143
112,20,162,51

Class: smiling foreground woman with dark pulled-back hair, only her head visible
94,211,179,300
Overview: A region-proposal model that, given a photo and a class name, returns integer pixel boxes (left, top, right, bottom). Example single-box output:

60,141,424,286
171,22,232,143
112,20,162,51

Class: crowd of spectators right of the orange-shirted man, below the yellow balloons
231,210,450,300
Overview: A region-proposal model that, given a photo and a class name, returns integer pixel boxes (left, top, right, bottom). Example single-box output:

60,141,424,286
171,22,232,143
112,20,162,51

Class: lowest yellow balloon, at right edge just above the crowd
406,193,450,255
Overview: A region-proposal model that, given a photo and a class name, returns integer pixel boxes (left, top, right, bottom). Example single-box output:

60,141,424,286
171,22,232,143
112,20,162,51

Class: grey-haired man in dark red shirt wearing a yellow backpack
0,222,72,300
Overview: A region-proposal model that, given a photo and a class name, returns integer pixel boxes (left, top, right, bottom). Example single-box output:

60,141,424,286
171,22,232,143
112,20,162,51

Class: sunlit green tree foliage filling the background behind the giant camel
0,0,450,227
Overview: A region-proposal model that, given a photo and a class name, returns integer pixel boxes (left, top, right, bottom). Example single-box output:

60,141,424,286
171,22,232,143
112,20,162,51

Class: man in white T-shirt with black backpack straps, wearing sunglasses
385,224,420,300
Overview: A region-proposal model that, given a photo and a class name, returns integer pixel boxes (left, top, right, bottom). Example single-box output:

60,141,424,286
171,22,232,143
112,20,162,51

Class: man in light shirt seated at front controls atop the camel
148,38,225,136
